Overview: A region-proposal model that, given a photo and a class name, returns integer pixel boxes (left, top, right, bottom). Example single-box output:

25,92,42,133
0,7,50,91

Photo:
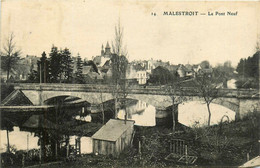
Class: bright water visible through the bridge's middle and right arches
117,100,236,127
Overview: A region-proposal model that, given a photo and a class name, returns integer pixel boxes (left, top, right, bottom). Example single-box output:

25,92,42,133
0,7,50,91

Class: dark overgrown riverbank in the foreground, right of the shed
4,109,260,168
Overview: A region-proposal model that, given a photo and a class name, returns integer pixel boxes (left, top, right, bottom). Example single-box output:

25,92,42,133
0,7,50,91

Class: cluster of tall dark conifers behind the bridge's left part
29,46,83,83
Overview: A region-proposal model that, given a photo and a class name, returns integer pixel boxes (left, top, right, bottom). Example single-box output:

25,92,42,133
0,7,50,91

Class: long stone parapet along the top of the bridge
11,83,259,99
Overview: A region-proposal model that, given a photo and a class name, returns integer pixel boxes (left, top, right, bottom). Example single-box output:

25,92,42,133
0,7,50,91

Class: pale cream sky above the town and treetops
0,0,260,66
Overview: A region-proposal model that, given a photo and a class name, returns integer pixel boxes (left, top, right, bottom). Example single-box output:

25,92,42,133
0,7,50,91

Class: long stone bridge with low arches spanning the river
2,84,260,117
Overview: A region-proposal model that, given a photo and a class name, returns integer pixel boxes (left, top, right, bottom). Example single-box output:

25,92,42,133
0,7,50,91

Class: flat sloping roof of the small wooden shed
92,119,134,141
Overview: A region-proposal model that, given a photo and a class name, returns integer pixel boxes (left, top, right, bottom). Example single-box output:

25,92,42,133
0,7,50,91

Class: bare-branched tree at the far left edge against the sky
1,33,21,81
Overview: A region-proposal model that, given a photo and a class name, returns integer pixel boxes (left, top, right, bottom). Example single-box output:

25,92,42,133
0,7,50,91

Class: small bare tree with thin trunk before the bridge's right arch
195,73,219,126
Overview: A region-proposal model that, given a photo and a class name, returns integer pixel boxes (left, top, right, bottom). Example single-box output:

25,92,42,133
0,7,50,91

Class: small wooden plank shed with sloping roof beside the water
92,119,134,157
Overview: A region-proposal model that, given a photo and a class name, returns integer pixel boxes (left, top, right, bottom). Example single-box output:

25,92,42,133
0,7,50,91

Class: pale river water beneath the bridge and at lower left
1,98,235,153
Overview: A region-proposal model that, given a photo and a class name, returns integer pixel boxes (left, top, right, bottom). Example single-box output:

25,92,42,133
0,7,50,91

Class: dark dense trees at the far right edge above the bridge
236,51,260,88
